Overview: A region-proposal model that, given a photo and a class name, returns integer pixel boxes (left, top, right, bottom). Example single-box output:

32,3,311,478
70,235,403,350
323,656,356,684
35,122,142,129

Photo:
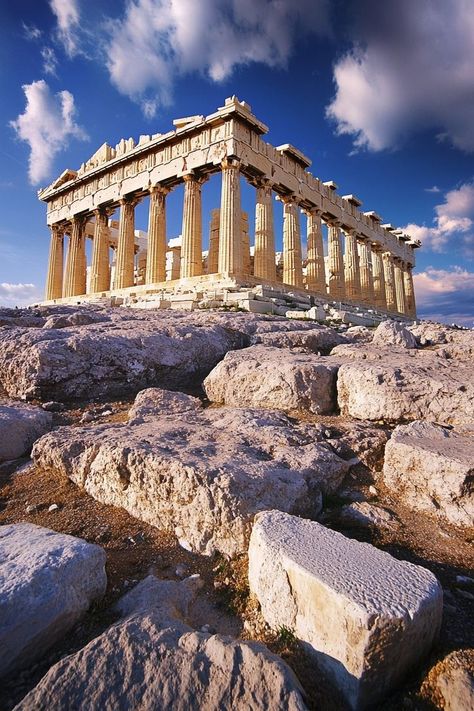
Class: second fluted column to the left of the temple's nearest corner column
145,185,169,284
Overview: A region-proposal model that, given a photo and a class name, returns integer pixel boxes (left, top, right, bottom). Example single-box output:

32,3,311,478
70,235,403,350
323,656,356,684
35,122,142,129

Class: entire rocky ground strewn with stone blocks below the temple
0,307,474,711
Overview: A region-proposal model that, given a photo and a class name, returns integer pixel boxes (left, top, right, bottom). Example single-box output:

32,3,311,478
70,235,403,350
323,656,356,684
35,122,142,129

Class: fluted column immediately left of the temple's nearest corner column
181,173,204,279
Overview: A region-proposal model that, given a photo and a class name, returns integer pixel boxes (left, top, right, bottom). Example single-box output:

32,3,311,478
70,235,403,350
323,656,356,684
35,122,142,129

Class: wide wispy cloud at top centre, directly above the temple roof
106,0,329,118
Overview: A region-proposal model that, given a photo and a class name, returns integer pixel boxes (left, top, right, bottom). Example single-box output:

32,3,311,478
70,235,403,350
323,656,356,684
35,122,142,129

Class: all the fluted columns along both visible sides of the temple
46,158,416,316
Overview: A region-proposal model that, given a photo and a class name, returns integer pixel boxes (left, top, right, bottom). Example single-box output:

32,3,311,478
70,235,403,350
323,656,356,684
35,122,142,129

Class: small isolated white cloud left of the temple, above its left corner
10,80,87,184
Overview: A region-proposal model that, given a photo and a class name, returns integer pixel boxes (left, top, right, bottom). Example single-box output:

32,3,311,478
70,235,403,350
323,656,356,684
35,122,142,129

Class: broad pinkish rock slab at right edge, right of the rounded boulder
331,344,474,424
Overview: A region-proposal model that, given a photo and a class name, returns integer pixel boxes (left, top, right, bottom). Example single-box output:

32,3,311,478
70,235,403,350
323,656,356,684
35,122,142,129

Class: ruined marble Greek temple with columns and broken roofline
38,97,420,318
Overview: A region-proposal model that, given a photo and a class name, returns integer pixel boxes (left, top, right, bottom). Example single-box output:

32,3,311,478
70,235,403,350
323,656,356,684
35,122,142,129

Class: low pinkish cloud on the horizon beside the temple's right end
414,266,474,328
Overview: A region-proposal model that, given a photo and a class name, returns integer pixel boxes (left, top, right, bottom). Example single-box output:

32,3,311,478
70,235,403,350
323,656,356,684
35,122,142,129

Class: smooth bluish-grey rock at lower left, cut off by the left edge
0,523,107,676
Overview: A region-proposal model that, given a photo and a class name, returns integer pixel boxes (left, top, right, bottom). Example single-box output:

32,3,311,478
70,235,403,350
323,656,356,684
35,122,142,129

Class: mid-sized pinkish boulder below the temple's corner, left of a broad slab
204,345,339,415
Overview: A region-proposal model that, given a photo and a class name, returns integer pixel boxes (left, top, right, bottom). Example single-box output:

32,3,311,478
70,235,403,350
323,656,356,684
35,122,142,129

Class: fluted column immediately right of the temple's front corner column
253,180,276,281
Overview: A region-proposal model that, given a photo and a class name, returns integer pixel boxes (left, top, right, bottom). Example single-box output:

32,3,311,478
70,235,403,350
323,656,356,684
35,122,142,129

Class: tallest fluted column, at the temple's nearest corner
218,158,242,274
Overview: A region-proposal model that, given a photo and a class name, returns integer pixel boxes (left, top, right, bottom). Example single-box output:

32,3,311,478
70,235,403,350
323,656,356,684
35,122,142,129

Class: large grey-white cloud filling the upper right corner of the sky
327,0,474,151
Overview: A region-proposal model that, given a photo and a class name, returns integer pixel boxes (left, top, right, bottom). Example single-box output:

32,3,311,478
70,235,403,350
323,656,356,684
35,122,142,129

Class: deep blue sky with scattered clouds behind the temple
0,0,474,326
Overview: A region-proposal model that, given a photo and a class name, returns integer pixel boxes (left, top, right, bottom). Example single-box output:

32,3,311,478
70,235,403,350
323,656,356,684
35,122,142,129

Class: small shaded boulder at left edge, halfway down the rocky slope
0,400,53,462
